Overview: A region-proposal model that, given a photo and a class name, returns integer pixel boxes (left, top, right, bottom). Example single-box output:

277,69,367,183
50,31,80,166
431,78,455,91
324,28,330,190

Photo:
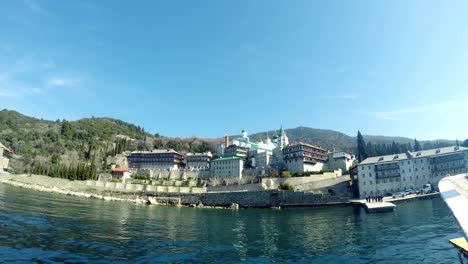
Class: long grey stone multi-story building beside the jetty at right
358,146,468,197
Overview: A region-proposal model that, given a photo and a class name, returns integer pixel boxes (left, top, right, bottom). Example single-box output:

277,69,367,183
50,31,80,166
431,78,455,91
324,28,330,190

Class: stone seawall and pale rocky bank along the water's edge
0,173,348,208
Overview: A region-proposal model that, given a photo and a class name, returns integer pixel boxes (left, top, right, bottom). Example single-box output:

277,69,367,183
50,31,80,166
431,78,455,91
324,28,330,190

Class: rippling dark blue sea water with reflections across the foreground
0,185,462,263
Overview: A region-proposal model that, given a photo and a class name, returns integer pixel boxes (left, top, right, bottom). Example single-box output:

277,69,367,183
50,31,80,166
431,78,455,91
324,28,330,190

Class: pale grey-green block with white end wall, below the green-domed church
210,157,244,179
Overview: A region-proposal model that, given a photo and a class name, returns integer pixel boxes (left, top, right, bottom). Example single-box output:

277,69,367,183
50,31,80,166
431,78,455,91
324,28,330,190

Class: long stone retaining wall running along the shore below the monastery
0,174,348,208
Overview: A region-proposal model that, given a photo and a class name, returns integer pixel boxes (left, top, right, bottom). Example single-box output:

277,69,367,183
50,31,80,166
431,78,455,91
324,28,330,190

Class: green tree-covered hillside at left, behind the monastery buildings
0,109,219,172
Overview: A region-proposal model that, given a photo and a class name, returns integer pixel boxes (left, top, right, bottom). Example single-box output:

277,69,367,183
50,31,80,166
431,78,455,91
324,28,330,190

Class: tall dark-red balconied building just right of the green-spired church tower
283,143,327,173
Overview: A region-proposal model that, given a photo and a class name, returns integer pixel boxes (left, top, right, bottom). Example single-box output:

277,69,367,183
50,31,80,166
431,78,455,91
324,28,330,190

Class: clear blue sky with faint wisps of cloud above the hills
0,0,468,139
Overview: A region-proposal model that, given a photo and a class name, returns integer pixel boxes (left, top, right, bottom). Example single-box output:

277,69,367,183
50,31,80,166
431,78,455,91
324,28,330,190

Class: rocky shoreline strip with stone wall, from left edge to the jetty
0,173,350,209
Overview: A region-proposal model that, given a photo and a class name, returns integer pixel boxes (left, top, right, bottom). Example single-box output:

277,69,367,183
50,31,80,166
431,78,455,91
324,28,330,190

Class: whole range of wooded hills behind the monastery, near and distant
0,109,454,172
